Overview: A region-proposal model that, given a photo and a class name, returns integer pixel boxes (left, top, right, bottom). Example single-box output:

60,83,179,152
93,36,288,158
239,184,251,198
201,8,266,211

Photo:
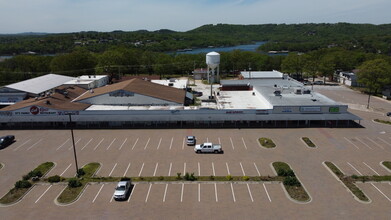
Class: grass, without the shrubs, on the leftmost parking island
0,162,54,205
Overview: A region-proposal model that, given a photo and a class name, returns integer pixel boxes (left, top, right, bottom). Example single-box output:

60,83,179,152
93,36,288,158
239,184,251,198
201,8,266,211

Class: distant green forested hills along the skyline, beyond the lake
0,23,391,55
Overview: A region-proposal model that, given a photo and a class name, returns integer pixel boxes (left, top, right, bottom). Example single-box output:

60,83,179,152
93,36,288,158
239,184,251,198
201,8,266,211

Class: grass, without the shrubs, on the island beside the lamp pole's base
57,163,100,204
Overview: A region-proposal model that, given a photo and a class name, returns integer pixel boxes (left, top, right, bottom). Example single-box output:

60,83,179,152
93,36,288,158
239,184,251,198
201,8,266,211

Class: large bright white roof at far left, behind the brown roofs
5,74,74,94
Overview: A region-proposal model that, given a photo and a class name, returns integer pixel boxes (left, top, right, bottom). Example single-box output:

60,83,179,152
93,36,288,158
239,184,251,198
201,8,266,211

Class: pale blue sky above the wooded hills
0,0,391,33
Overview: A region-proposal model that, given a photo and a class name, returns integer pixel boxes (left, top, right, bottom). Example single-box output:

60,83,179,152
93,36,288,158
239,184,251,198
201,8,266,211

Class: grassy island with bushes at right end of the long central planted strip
273,162,310,202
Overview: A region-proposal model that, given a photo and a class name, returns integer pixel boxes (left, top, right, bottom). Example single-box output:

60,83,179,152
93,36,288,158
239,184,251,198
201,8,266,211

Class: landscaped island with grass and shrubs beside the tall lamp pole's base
57,163,100,204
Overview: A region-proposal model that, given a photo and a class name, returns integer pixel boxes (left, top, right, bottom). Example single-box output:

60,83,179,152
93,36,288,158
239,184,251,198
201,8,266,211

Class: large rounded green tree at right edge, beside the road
357,59,391,108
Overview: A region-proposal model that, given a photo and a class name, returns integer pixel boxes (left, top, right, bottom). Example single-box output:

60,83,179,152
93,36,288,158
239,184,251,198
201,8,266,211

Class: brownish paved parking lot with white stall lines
0,118,391,219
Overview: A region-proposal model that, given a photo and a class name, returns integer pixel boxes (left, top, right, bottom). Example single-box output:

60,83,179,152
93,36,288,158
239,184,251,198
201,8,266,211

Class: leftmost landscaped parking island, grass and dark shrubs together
0,162,54,205
